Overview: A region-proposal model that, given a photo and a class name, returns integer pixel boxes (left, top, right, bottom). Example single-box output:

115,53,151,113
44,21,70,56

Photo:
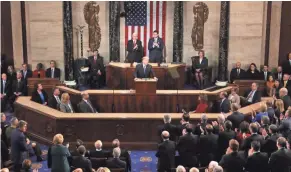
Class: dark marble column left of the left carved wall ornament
63,1,74,80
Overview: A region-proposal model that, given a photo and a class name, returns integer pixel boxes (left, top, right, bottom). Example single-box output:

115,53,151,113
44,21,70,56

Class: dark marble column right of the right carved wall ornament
218,1,230,81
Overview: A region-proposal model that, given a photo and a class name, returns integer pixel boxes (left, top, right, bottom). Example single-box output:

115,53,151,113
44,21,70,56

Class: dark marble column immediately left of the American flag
109,1,120,62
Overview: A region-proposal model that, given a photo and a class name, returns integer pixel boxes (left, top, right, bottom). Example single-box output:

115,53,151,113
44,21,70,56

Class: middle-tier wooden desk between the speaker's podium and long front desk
59,86,232,113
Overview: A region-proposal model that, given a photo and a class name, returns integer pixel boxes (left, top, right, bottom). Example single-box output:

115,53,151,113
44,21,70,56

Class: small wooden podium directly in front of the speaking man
134,78,157,94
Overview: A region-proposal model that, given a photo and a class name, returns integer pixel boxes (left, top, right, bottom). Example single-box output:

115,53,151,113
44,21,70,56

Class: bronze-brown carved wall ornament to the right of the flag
191,2,209,51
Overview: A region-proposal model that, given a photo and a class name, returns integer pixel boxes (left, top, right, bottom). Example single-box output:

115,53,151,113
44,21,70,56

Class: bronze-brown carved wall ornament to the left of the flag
84,1,101,51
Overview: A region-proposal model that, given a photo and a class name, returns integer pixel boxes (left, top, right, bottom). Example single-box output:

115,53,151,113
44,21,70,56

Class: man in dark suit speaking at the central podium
134,57,157,79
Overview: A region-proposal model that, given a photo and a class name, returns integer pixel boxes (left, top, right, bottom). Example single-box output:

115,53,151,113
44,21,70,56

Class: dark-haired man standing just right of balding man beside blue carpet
177,124,199,167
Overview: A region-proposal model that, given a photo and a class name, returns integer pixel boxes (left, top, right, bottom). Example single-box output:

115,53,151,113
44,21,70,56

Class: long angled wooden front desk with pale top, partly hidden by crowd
15,97,272,150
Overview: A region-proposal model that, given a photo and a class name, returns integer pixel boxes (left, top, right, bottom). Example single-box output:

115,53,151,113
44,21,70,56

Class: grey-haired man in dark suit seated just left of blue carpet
106,147,126,169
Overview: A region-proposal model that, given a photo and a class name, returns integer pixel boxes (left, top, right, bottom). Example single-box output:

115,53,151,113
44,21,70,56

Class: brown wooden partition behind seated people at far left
27,78,62,96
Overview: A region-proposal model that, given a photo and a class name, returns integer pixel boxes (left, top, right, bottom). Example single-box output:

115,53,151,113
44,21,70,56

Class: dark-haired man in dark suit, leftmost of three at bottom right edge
219,139,245,172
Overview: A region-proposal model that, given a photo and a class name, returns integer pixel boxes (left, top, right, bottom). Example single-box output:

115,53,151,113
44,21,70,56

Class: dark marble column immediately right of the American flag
173,1,183,62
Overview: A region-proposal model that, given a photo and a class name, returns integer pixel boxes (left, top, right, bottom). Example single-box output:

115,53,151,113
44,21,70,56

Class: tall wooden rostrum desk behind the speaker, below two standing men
106,62,186,90
